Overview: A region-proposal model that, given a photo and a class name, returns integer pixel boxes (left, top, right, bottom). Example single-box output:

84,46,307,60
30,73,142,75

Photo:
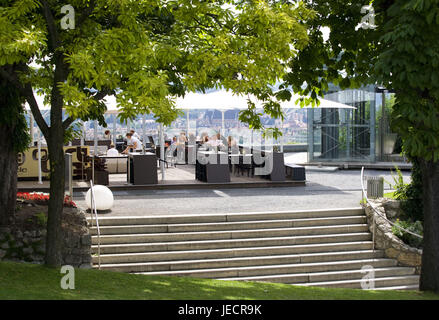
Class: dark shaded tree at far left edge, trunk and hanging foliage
0,77,30,226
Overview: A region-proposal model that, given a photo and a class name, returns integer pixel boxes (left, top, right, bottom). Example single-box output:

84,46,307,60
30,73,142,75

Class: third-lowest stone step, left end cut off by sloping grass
134,259,402,281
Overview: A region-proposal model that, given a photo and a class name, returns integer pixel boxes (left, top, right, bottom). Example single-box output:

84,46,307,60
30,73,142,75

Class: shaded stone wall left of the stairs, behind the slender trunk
0,204,92,268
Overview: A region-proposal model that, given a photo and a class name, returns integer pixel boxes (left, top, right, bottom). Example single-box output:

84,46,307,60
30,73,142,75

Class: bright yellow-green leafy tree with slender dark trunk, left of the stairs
0,0,313,266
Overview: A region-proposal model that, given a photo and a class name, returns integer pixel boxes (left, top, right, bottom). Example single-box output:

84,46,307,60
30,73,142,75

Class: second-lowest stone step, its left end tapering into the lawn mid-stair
219,267,415,288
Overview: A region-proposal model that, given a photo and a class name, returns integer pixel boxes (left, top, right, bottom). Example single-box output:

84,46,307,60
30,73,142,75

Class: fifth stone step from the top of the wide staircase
92,241,372,264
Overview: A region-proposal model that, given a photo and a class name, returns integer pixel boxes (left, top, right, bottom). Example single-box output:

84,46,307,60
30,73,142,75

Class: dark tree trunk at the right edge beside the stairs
420,160,439,292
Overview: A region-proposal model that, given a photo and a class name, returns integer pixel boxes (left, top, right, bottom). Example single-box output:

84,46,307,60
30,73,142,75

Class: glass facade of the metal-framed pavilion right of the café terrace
308,86,377,162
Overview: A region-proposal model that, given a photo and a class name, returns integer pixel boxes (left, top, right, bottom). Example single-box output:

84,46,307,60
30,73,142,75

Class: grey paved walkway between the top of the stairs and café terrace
74,170,410,216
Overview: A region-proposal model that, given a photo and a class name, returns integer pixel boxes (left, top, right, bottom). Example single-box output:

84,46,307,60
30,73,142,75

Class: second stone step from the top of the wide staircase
90,216,366,235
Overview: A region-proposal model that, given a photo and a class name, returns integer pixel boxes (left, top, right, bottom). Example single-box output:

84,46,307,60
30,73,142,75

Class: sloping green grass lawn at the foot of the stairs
0,262,439,300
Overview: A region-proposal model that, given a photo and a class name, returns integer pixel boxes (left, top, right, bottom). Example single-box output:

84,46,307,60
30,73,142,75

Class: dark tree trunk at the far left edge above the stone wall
0,122,17,226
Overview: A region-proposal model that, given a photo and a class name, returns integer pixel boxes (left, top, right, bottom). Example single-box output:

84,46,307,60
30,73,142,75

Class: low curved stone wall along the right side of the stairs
365,199,422,274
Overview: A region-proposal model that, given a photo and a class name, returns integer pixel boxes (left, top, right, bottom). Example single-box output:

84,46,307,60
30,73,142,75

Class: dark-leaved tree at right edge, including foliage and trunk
278,0,439,291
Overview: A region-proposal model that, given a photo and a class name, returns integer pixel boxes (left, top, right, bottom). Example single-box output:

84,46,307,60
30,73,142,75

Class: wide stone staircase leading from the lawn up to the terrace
91,208,419,289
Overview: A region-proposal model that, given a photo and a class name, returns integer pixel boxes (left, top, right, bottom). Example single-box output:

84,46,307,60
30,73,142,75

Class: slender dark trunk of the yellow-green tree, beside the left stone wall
45,122,65,267
